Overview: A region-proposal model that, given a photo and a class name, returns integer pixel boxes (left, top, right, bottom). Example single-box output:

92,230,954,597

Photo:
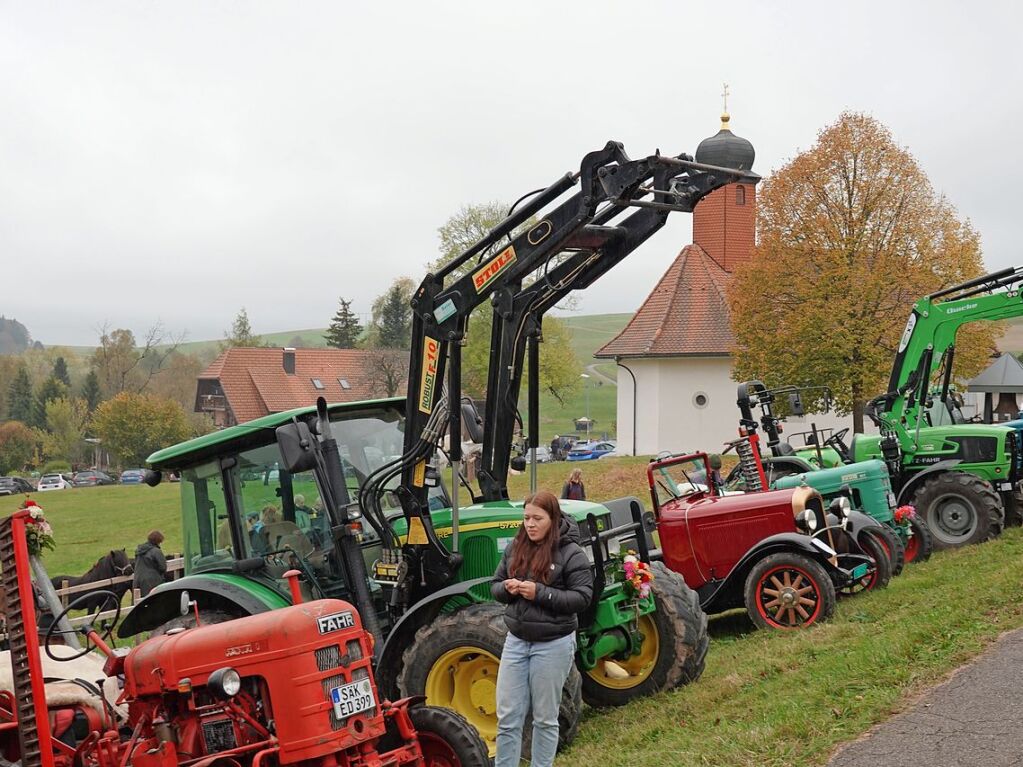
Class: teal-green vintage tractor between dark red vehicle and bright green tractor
725,380,933,575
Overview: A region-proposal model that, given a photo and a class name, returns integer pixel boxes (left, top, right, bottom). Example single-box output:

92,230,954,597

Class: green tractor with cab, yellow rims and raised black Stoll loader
120,142,757,749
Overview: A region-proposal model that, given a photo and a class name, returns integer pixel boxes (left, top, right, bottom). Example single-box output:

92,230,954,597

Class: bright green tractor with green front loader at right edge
796,268,1023,548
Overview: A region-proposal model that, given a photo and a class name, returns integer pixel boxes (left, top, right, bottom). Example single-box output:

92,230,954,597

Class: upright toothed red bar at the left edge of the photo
0,517,42,767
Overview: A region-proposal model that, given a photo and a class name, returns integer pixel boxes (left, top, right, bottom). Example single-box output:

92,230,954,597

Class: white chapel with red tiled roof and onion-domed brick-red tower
594,112,851,455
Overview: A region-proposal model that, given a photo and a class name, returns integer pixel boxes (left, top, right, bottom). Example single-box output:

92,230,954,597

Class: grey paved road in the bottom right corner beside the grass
828,630,1023,767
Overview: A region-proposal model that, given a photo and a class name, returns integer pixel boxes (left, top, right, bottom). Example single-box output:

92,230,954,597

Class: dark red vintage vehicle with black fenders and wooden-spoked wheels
647,436,891,629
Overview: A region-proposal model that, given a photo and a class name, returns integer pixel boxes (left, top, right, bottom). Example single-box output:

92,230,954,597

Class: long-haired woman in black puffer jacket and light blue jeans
490,490,593,767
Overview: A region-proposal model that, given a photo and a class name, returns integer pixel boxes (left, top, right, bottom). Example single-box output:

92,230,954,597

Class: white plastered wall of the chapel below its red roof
618,357,852,455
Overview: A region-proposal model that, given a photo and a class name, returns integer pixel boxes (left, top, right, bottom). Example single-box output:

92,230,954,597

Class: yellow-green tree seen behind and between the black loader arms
428,202,581,403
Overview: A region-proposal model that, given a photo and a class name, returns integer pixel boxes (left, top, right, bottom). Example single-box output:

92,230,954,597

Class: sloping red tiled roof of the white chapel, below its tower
593,244,735,358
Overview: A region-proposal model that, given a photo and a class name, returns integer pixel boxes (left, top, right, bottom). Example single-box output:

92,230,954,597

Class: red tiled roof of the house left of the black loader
198,348,392,423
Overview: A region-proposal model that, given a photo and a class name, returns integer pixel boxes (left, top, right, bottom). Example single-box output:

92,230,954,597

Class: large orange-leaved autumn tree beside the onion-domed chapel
728,112,994,432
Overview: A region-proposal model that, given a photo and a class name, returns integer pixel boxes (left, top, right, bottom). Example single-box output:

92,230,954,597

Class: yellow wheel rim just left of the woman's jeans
426,644,500,756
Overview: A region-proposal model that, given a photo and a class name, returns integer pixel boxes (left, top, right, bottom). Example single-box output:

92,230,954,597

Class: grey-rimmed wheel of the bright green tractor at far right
913,471,1005,550
